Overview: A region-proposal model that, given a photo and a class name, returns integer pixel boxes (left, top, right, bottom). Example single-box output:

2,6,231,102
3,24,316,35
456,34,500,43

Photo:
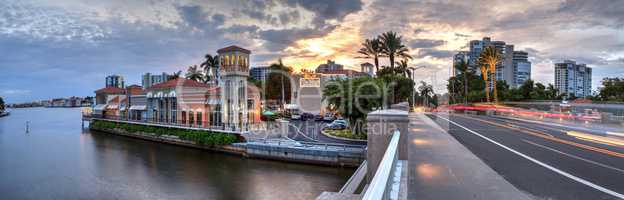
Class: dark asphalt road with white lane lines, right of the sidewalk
429,115,624,200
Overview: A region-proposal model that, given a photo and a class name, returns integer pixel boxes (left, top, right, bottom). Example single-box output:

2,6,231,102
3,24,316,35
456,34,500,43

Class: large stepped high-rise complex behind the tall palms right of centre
453,37,531,87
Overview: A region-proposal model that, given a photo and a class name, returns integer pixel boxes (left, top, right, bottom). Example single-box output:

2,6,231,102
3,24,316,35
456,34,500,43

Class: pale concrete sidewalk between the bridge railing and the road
407,113,531,200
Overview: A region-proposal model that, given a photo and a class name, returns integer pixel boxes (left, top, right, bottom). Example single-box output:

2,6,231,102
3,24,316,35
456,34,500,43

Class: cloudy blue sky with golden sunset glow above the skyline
0,0,624,103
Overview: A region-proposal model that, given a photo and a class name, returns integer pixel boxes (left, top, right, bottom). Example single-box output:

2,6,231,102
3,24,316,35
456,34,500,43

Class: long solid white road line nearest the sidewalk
438,116,624,199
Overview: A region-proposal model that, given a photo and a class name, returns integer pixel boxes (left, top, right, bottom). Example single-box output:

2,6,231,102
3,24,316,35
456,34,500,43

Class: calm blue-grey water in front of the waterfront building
0,108,354,199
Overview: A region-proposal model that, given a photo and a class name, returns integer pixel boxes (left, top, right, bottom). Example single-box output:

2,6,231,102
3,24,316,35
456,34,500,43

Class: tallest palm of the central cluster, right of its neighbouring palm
379,31,412,69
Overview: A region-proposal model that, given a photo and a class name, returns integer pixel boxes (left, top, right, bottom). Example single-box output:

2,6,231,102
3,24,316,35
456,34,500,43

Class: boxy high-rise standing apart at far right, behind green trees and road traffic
555,60,592,97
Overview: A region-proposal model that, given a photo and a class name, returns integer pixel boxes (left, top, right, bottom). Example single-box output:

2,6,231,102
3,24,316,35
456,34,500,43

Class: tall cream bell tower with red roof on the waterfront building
217,45,251,130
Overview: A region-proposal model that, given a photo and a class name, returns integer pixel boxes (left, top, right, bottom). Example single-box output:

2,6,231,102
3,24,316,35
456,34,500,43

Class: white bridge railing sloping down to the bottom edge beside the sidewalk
362,130,402,200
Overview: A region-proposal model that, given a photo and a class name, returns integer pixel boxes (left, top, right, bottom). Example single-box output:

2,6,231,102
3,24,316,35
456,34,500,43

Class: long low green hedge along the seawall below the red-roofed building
90,120,237,146
